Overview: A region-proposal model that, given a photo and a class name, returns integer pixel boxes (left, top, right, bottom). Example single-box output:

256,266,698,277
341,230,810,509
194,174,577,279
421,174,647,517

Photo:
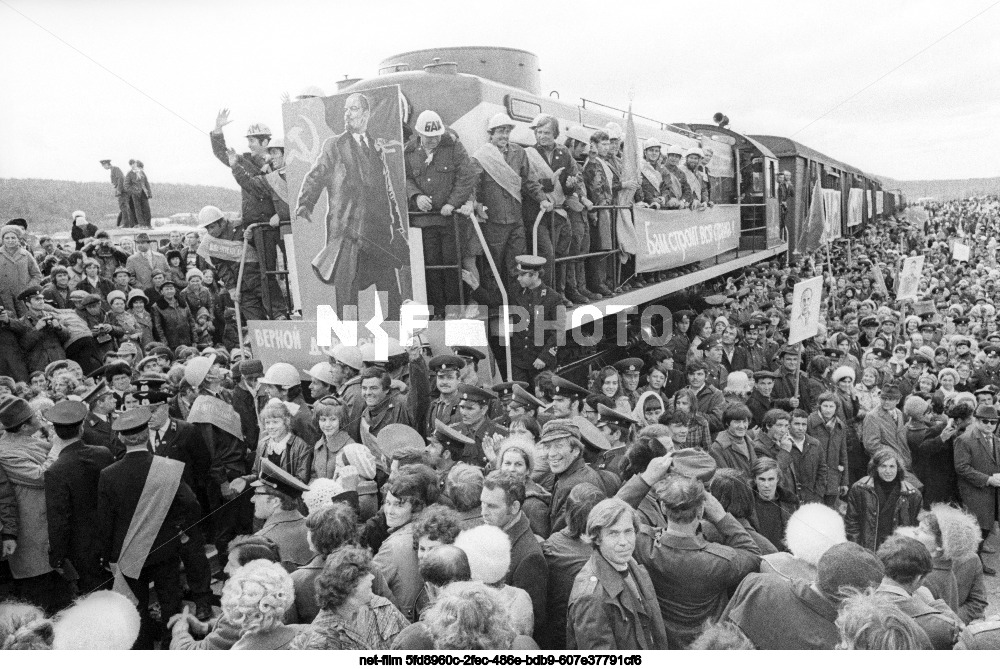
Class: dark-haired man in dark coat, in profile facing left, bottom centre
479,471,549,636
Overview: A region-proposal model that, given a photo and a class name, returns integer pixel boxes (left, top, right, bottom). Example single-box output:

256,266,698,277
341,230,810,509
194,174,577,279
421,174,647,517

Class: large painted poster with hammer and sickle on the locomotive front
282,86,412,319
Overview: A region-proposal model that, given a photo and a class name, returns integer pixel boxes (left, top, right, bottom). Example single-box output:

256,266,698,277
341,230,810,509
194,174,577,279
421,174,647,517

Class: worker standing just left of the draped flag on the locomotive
583,130,621,297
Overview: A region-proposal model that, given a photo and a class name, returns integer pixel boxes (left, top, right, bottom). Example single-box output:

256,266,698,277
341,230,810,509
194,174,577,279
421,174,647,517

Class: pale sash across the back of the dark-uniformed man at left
112,455,184,604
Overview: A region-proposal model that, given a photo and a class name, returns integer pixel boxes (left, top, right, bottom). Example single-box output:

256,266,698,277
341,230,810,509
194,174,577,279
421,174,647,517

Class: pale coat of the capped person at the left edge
0,432,52,578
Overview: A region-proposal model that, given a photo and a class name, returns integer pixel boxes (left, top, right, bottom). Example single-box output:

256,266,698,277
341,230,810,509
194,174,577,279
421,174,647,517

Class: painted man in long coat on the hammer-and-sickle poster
295,92,410,313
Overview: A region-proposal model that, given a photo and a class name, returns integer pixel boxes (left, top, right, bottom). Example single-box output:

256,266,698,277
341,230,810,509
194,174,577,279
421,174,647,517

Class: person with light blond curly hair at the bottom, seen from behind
222,560,301,650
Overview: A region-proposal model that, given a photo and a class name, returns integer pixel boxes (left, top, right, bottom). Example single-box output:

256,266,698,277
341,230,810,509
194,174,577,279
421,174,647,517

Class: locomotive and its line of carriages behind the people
264,46,902,373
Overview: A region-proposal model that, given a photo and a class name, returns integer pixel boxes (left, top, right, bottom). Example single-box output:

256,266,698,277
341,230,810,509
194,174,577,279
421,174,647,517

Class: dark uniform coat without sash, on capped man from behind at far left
45,441,114,590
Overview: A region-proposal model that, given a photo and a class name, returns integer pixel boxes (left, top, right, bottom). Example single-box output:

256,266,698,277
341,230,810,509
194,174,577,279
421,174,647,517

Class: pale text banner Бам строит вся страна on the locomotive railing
635,205,740,272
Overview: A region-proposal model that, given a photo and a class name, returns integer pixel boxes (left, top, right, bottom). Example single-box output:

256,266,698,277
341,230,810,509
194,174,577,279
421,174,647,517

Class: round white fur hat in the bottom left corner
52,590,139,650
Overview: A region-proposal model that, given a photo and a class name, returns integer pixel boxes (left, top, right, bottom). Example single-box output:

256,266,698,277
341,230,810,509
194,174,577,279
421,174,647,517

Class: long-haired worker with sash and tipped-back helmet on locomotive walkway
524,114,592,306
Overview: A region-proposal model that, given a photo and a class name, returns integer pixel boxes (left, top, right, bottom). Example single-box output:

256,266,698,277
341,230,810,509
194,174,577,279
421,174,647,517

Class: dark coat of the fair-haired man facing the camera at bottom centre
566,550,667,650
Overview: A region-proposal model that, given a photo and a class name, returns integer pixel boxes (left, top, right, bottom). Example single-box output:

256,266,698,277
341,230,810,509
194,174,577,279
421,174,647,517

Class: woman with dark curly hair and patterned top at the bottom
291,546,375,650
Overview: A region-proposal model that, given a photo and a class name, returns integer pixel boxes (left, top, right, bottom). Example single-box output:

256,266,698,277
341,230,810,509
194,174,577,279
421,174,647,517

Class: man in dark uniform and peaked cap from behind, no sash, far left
45,400,114,593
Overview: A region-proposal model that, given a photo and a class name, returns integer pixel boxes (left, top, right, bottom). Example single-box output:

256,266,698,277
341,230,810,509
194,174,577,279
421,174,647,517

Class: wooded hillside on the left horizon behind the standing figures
0,179,240,233
